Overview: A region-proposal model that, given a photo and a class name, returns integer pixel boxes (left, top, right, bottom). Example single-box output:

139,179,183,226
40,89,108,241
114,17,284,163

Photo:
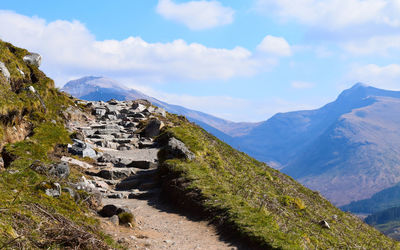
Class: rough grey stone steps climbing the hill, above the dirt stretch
69,100,166,199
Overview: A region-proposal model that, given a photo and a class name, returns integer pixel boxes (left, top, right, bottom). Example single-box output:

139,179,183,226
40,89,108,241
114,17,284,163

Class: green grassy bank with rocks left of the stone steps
0,40,117,249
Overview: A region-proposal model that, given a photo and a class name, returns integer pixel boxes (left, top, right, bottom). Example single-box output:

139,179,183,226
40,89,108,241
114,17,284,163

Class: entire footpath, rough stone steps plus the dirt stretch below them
64,100,236,249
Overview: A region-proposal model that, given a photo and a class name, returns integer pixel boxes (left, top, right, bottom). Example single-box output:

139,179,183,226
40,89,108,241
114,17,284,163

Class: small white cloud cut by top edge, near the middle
157,0,235,30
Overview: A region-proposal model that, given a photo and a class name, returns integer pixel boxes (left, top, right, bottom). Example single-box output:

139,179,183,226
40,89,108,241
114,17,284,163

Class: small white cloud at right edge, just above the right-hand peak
342,35,400,56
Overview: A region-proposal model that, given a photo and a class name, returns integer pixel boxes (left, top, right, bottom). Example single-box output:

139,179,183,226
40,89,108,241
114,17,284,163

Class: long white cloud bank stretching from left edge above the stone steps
0,11,284,85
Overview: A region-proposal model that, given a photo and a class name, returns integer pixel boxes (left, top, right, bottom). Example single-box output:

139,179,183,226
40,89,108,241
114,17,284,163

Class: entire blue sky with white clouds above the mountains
0,0,400,122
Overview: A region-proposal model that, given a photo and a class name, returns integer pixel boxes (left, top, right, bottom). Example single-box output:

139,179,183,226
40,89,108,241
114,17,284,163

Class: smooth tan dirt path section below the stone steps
103,198,237,250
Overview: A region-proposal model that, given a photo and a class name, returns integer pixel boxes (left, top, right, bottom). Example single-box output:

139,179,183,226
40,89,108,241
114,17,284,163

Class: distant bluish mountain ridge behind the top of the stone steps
61,76,258,139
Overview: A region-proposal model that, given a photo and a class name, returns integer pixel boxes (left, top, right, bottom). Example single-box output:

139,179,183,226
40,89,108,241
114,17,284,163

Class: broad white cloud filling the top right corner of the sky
256,0,400,29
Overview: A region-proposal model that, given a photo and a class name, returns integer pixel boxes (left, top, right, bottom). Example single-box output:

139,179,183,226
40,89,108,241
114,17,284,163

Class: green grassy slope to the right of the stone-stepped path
160,116,400,249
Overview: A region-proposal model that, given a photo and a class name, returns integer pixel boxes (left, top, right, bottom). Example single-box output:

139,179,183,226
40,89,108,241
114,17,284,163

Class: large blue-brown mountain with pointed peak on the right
235,83,400,205
